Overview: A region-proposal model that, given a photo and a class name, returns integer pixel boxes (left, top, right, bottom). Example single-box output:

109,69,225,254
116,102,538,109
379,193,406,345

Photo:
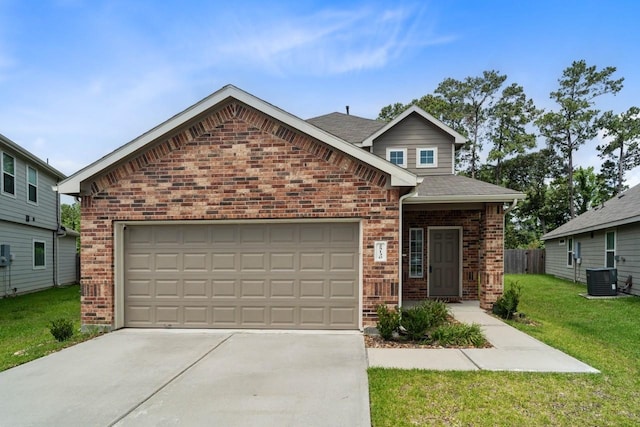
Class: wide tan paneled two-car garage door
124,223,359,329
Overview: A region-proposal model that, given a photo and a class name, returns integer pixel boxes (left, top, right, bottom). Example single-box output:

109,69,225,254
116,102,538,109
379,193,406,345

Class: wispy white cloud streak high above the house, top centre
212,6,454,75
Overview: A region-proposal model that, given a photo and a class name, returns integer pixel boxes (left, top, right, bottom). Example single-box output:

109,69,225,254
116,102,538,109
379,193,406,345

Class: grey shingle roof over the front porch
404,175,525,204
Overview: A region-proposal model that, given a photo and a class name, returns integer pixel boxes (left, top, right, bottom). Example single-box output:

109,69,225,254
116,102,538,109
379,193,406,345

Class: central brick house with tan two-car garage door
58,86,524,329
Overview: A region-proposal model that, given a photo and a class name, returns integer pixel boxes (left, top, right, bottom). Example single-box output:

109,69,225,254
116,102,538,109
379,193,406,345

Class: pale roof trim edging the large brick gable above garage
58,85,420,195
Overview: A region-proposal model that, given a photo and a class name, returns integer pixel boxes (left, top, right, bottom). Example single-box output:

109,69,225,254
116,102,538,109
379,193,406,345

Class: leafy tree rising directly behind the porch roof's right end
487,83,541,185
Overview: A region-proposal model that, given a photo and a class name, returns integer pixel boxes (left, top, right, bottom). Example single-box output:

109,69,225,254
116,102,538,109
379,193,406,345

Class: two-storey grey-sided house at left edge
0,135,79,296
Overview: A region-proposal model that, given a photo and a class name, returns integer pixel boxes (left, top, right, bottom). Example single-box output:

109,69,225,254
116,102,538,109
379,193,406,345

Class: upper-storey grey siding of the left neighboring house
0,146,58,230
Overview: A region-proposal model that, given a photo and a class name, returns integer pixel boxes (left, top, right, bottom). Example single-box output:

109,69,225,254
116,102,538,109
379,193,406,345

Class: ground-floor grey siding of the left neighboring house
0,221,54,295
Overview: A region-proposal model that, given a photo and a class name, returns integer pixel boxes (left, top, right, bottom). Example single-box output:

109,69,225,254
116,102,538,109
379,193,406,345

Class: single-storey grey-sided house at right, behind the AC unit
542,185,640,295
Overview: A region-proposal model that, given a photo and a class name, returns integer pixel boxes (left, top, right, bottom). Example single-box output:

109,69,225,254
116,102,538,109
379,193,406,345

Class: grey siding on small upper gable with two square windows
373,114,454,176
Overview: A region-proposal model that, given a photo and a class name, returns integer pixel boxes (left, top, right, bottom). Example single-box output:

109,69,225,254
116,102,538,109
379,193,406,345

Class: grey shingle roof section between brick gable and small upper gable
307,112,386,144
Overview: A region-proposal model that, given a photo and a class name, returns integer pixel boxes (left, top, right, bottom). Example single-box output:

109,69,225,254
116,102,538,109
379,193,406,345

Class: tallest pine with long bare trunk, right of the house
536,60,624,218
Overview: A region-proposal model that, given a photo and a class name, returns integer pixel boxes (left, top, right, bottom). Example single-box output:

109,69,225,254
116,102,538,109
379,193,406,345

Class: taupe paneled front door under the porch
429,228,460,297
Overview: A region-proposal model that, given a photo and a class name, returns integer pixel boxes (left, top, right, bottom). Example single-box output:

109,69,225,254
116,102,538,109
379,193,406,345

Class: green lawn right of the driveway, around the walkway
369,275,640,426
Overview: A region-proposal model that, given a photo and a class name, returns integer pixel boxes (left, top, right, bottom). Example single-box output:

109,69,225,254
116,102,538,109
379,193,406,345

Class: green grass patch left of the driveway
0,285,95,371
